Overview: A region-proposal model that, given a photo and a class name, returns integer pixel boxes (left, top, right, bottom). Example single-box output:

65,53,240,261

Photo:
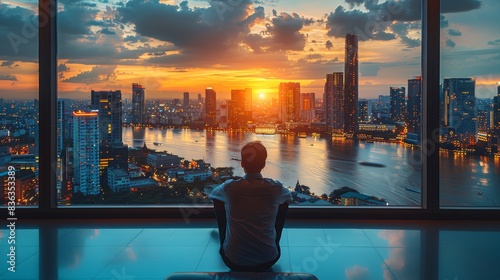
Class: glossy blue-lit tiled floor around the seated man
0,220,500,280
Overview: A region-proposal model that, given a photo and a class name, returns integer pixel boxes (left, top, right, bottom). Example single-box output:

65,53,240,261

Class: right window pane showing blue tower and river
439,0,500,207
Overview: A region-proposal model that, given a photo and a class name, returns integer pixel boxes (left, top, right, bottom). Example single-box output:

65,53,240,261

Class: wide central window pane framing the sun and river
57,0,422,207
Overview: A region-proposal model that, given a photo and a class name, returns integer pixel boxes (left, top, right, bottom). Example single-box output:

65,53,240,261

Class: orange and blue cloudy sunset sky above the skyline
0,0,500,99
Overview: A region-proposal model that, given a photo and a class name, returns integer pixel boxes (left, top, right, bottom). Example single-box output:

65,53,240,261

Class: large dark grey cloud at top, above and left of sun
118,0,265,55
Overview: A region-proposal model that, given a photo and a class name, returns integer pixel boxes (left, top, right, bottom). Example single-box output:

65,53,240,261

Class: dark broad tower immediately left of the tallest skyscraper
325,72,344,134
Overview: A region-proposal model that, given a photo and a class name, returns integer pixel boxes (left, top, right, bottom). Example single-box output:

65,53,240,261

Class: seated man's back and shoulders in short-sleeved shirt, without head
210,173,292,266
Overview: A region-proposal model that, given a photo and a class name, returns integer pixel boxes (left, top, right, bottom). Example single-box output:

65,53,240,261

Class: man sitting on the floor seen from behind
209,141,292,271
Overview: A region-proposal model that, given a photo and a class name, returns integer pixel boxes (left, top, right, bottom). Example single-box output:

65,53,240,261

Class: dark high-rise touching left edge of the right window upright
406,77,422,135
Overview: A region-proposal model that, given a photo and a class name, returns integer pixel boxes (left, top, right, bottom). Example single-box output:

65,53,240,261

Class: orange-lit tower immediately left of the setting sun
229,88,252,128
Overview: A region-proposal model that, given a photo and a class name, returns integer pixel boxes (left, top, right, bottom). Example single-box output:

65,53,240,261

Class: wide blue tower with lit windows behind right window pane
443,78,477,144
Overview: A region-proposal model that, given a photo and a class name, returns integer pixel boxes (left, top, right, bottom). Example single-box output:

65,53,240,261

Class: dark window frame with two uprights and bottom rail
8,0,500,220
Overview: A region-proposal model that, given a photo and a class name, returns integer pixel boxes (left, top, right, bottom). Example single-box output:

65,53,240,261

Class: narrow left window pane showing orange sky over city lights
0,0,39,206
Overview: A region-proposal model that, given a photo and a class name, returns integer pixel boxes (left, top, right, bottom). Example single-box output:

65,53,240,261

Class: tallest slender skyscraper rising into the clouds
344,34,358,139
